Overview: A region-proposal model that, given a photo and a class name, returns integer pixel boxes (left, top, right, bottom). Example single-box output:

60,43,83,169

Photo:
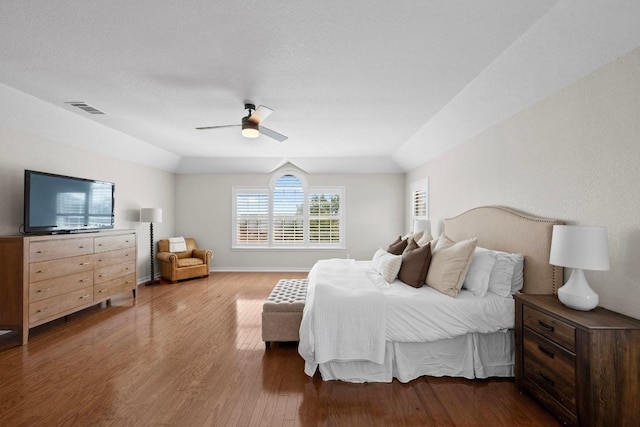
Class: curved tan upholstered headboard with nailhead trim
444,206,563,294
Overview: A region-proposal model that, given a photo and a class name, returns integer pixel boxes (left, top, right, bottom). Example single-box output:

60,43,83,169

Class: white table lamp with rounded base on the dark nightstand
549,225,609,311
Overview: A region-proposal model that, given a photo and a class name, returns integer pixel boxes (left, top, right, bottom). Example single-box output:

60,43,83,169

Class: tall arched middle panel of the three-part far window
272,175,304,245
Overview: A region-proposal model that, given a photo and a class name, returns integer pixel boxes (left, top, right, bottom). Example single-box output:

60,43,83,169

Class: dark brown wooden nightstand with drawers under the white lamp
515,294,640,426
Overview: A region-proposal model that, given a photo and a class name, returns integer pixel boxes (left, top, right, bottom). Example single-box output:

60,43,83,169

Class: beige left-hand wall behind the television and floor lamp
0,126,174,281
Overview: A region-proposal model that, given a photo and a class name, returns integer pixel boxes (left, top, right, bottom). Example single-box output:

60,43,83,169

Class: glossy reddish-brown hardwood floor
0,273,558,426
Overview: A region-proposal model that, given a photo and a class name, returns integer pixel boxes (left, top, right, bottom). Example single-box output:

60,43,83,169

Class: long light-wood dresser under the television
0,230,137,344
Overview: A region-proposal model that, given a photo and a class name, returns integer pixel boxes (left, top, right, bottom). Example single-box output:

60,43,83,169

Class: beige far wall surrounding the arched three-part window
176,174,405,271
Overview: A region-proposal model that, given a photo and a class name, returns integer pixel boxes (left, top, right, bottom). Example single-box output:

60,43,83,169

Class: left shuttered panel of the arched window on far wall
235,189,269,246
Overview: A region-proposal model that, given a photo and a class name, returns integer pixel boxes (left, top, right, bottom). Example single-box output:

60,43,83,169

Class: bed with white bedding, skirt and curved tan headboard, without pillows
298,207,563,382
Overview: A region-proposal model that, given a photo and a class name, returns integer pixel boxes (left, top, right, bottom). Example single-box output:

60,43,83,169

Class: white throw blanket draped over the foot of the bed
298,259,386,375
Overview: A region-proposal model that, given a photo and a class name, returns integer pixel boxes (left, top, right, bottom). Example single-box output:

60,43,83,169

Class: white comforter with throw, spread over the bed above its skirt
298,259,514,375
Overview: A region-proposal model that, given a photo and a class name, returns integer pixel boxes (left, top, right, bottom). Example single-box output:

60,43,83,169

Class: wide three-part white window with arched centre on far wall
233,171,345,249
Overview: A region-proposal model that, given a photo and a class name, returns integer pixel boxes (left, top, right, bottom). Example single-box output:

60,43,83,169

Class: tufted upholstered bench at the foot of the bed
262,279,309,348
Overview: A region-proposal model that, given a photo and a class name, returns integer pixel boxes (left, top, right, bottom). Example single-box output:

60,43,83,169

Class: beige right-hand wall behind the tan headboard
407,49,640,318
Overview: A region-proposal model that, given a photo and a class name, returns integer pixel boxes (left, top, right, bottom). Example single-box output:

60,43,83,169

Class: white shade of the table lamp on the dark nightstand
549,225,609,270
